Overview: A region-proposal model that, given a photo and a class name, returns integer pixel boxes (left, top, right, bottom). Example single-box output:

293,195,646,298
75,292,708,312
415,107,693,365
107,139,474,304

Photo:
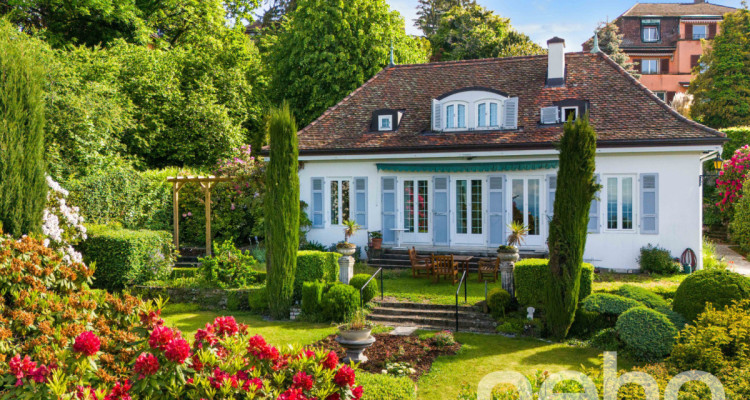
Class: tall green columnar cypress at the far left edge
0,29,47,237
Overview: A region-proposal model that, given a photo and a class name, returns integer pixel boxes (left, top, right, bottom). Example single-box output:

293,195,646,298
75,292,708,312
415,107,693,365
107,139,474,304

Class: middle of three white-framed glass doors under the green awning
454,178,485,245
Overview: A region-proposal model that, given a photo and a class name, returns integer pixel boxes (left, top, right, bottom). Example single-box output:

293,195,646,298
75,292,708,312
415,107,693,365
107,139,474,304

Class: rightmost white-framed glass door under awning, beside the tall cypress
511,178,544,246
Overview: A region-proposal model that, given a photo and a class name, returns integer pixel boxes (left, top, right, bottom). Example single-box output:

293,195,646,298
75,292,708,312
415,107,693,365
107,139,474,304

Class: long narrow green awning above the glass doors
377,160,558,173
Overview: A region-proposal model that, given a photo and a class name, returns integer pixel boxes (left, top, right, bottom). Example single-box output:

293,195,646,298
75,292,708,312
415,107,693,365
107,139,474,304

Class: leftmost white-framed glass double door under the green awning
403,179,432,243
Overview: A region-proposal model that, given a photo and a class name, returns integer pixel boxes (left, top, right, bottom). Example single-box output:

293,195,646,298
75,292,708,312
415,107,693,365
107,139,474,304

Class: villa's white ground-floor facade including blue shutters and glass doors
300,146,717,270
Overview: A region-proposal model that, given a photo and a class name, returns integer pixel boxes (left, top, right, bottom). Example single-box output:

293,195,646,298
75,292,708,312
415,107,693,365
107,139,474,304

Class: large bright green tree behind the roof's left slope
266,0,427,126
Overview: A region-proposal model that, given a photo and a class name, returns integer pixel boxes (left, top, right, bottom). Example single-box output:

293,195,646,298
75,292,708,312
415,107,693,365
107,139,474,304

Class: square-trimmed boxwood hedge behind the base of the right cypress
513,258,594,308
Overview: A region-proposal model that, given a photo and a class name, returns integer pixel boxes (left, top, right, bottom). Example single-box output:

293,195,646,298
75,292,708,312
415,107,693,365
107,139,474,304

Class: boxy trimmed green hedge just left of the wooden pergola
79,227,174,290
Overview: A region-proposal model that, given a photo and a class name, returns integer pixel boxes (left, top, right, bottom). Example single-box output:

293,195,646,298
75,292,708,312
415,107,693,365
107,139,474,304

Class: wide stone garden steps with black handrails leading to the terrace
367,300,497,333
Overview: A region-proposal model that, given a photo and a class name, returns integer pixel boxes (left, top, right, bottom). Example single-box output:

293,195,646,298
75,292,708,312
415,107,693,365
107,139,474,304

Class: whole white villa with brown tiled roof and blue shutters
299,38,726,270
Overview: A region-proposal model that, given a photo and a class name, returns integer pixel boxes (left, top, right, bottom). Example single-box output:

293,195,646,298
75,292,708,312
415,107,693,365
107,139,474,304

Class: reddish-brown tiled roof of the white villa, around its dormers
299,53,725,154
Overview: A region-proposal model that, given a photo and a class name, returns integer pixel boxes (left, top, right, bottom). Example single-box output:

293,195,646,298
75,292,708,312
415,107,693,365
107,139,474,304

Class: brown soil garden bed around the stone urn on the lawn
313,333,461,382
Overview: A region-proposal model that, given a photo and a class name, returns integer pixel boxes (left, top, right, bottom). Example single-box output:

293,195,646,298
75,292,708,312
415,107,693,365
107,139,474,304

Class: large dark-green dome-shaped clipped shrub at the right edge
672,270,750,321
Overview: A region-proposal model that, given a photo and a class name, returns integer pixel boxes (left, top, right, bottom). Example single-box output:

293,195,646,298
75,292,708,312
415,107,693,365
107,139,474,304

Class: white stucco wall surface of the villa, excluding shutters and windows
300,148,706,270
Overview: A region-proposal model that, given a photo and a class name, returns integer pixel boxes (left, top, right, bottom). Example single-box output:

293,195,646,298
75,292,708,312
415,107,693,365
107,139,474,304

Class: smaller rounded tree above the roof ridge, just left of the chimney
429,3,545,60
